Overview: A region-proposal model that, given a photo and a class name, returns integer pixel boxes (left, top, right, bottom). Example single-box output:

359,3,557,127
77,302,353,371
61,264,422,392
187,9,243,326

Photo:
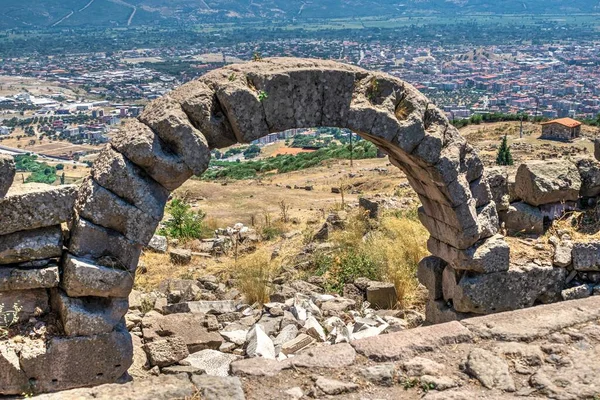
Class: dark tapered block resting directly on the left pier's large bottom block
51,289,128,336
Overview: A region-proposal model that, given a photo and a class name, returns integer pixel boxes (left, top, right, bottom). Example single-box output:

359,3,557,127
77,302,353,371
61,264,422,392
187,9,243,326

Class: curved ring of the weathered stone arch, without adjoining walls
52,58,508,390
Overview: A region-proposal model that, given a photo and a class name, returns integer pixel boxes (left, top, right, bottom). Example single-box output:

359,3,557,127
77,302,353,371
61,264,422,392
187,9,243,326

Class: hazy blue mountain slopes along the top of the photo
0,0,600,29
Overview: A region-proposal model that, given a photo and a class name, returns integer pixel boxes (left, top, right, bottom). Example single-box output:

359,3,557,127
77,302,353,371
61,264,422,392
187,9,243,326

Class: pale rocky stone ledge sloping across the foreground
39,297,600,400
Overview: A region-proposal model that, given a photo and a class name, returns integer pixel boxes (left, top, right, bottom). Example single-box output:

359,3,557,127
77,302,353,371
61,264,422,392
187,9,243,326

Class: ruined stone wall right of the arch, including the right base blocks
419,158,600,323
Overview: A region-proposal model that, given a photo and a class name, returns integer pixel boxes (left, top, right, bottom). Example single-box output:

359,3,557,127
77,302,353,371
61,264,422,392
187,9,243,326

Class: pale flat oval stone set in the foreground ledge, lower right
466,347,516,392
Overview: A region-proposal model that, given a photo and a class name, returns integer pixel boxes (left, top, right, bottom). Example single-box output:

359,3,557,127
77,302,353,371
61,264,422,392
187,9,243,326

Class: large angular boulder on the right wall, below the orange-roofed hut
515,160,581,206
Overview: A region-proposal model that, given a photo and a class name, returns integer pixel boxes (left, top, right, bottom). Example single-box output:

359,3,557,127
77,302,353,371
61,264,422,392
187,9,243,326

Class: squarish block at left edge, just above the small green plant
0,289,50,326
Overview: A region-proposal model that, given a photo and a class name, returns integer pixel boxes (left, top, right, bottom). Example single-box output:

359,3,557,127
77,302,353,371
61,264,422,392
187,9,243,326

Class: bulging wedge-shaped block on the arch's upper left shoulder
140,96,212,176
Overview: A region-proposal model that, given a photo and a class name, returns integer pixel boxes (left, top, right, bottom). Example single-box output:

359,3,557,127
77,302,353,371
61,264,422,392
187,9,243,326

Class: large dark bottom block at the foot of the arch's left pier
15,326,133,399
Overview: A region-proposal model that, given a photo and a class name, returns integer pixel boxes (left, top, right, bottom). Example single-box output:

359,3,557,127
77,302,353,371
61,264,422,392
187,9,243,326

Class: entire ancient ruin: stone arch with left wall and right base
0,58,599,394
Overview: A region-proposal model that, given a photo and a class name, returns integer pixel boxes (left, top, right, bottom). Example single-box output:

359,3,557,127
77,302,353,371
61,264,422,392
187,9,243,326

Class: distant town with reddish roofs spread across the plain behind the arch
0,39,600,159
